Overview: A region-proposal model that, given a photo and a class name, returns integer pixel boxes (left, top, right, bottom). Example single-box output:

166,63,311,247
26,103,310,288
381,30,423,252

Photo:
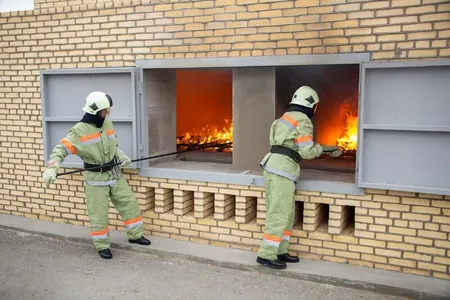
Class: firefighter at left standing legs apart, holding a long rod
43,92,151,259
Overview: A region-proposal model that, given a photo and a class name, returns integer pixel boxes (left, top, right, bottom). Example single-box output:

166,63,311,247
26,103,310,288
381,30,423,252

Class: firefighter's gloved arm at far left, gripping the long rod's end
43,129,80,187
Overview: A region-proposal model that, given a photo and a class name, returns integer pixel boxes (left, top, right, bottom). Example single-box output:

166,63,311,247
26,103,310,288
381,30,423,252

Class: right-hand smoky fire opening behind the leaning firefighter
276,65,359,173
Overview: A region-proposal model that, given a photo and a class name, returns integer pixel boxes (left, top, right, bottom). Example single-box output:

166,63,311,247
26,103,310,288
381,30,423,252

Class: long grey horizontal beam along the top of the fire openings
136,53,370,69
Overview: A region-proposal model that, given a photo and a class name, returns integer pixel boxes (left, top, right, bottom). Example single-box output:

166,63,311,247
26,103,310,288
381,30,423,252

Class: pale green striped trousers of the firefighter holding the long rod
86,177,144,251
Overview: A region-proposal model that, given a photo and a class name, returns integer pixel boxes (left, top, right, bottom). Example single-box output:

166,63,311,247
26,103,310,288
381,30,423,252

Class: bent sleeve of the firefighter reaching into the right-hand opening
294,119,323,159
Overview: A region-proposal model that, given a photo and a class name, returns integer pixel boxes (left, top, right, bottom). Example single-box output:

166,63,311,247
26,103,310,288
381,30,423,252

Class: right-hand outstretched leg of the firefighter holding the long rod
111,177,149,245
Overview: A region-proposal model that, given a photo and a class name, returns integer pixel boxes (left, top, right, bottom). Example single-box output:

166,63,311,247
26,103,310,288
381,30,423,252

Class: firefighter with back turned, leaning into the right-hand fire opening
256,86,342,269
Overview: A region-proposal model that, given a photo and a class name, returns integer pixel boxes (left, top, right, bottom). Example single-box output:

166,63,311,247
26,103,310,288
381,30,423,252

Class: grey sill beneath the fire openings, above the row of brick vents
139,167,364,195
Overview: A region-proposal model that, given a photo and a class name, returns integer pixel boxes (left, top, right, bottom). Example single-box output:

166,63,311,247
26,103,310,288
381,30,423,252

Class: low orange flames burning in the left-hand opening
177,119,233,152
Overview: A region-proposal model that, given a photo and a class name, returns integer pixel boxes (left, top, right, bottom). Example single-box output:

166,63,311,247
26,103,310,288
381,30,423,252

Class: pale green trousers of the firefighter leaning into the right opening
258,171,295,259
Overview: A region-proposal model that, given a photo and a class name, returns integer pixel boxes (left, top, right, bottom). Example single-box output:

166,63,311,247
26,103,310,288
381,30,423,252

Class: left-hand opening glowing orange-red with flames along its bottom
176,69,233,164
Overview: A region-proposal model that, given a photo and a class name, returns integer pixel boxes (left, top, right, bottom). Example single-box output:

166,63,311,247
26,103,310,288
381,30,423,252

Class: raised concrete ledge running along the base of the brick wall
0,214,450,299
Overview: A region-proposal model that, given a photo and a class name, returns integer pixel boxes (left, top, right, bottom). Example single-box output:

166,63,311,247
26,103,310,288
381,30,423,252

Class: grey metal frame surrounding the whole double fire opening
136,53,370,195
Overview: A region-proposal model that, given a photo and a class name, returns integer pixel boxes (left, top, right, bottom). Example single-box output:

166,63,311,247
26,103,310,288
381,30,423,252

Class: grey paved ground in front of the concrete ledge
0,229,407,300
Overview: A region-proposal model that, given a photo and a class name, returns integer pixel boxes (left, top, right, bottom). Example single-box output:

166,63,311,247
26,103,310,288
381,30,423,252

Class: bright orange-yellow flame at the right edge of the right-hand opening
337,99,358,150
